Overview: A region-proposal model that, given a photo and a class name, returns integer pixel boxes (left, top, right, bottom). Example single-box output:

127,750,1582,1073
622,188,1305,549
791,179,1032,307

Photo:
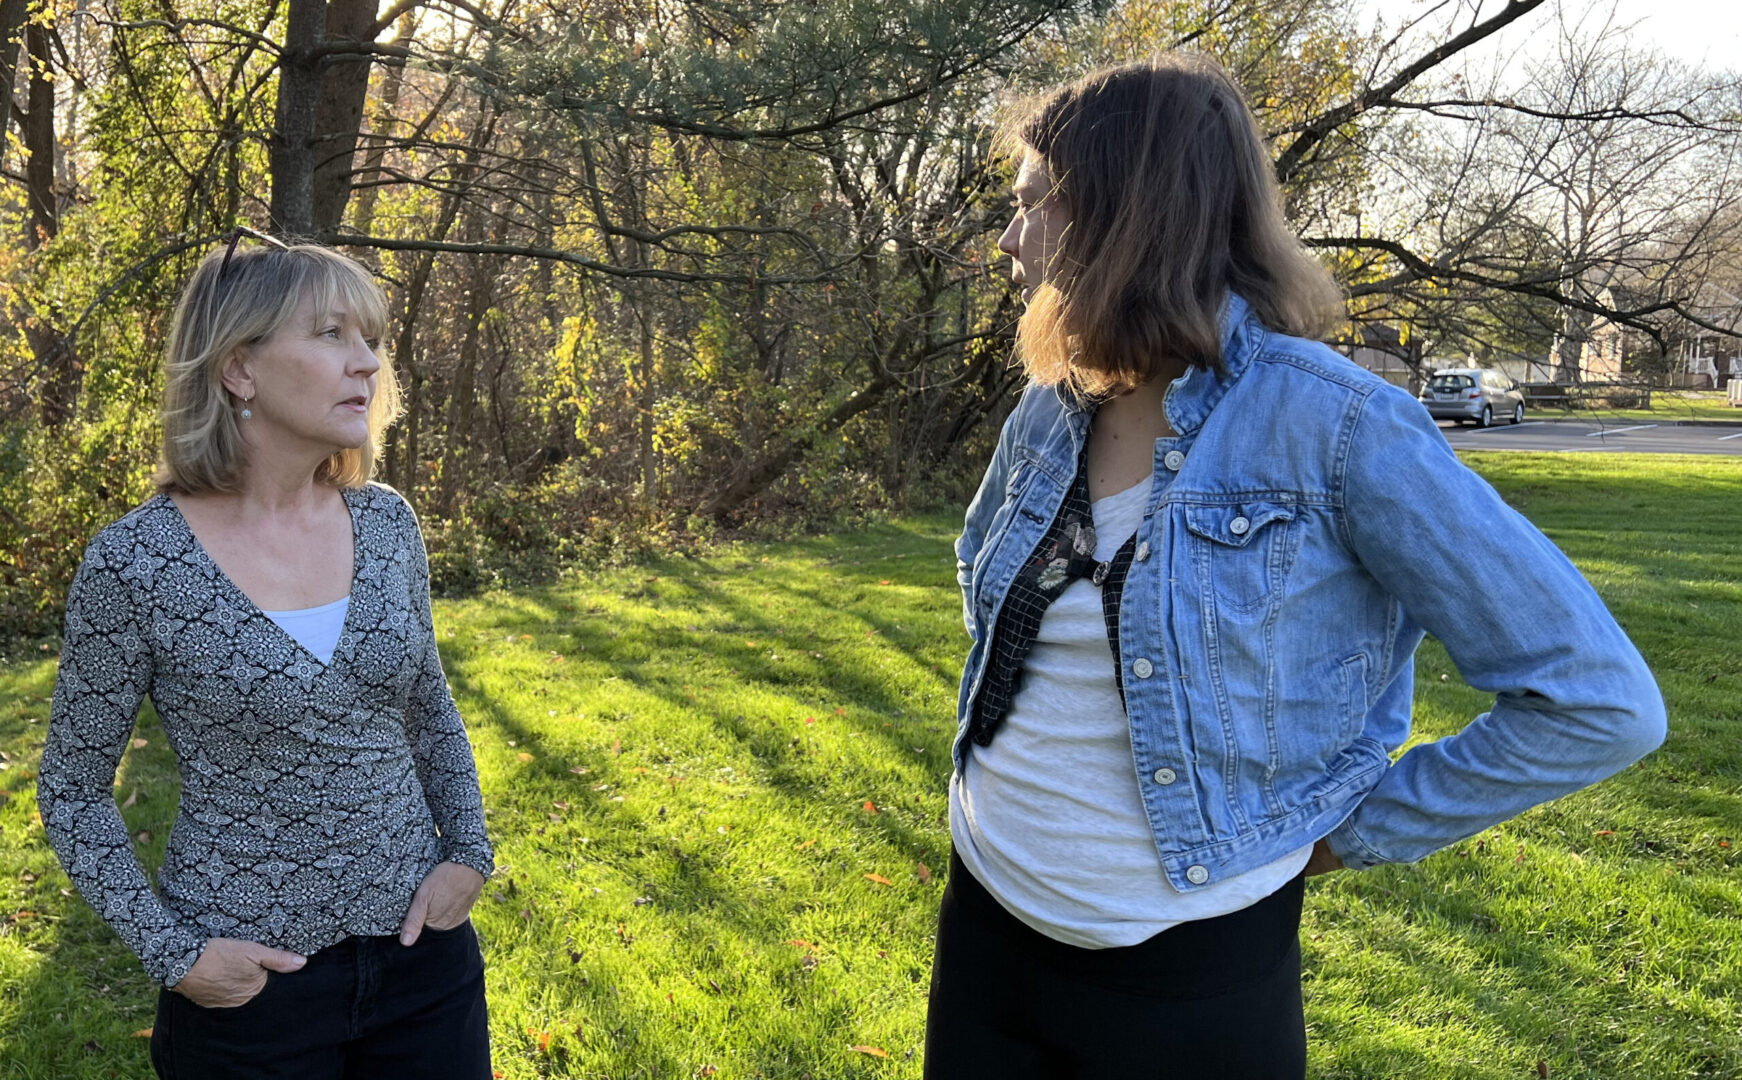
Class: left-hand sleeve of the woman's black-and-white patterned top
37,540,207,986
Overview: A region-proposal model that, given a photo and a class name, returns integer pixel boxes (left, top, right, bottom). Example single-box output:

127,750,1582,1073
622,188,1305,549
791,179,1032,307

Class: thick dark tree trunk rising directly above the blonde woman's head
267,0,327,237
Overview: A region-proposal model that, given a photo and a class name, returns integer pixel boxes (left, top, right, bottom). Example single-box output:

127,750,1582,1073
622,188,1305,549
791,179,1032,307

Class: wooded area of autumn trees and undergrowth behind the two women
0,0,1742,636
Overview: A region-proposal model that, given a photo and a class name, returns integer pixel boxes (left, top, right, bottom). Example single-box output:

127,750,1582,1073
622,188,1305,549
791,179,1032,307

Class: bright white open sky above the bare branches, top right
1364,0,1742,70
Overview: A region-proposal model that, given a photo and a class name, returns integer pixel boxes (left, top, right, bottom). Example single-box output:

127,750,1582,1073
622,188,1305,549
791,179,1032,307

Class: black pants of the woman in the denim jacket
925,854,1307,1080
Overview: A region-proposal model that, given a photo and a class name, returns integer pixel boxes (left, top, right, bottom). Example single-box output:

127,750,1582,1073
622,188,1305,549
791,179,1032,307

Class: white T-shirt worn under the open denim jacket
949,479,1312,949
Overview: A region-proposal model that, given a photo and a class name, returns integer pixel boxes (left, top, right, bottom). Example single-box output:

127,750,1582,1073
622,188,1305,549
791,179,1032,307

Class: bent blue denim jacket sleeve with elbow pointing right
1327,387,1667,869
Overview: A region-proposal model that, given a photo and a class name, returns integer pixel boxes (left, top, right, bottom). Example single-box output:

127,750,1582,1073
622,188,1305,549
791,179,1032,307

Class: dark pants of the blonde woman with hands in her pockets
152,921,490,1080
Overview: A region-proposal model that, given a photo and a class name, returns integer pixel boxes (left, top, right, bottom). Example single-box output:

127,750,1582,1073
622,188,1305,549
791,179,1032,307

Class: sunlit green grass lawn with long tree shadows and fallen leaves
0,453,1742,1080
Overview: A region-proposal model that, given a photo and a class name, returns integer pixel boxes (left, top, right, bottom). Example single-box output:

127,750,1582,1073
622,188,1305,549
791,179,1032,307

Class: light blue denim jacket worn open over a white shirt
953,294,1665,890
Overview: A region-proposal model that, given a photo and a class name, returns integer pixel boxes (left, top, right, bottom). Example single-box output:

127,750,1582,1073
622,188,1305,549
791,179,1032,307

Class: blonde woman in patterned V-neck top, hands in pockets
37,230,491,1080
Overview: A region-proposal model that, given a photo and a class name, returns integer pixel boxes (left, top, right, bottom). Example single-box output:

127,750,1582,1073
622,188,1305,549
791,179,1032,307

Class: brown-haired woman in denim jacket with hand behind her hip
925,54,1665,1080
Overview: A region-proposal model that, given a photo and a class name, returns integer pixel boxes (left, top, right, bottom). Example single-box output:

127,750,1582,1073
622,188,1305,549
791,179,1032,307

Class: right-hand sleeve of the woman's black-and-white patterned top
406,507,496,878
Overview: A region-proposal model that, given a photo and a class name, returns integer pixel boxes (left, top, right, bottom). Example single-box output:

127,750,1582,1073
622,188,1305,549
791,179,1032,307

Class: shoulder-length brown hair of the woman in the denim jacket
1005,52,1343,395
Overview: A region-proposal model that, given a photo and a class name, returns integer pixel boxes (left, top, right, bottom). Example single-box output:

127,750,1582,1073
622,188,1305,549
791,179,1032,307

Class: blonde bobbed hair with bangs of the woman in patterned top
152,244,399,493
